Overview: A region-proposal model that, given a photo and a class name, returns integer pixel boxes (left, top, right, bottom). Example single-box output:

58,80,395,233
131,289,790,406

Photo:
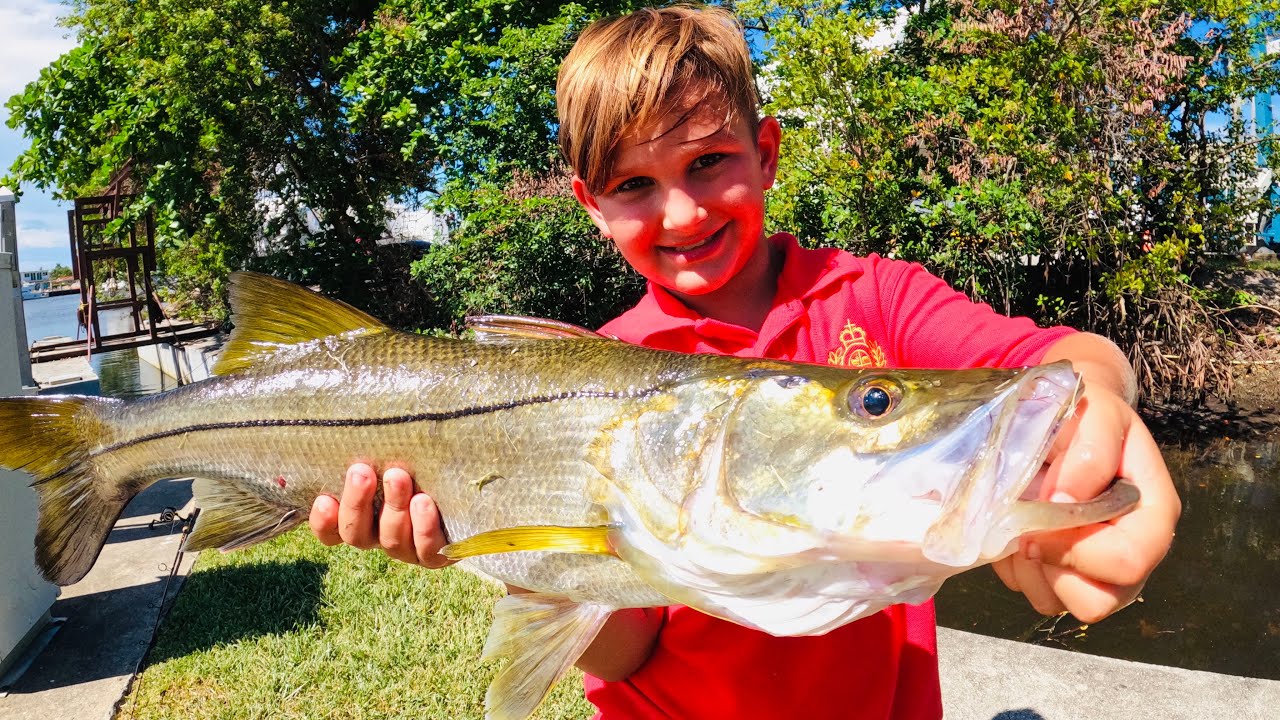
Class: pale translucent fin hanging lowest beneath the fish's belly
484,593,613,720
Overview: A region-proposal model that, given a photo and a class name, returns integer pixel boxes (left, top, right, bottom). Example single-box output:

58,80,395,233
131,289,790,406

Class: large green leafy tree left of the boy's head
8,0,625,324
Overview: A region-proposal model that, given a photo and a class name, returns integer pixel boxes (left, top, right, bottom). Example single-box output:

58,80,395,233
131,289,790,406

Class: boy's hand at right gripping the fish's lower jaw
993,383,1181,623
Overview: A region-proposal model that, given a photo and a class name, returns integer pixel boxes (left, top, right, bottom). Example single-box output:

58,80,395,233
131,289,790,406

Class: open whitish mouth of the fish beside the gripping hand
920,361,1083,568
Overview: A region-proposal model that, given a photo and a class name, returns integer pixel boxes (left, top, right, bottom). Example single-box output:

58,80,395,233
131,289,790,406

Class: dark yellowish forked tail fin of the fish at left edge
0,395,132,585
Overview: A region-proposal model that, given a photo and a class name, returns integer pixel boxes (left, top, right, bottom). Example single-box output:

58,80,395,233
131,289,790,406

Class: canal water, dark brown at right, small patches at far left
17,296,1280,680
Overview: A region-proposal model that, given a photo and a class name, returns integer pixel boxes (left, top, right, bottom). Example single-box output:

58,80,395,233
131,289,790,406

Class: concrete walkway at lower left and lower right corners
0,480,1280,720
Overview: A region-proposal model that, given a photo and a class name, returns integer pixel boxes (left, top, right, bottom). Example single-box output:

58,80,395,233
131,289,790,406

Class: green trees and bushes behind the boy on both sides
8,0,1280,395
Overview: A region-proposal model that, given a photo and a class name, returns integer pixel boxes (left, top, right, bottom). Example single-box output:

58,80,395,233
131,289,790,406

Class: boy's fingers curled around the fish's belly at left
310,462,453,568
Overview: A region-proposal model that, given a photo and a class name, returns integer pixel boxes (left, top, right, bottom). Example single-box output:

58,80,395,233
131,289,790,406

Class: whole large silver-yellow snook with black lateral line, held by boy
0,273,1138,719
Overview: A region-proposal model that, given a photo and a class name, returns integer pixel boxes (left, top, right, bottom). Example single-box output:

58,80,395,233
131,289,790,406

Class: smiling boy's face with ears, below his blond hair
573,96,781,296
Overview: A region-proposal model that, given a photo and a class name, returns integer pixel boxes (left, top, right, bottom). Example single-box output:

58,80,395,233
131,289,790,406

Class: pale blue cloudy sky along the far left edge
0,0,76,270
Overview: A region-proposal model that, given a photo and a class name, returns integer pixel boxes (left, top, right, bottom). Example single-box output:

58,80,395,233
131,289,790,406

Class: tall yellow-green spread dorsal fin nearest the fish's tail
214,272,388,375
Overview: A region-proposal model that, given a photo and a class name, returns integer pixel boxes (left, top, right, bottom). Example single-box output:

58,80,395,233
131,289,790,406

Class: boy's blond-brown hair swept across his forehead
556,5,760,192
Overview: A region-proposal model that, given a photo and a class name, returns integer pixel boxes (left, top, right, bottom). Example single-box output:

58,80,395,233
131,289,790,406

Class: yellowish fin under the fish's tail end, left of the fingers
182,478,306,551
